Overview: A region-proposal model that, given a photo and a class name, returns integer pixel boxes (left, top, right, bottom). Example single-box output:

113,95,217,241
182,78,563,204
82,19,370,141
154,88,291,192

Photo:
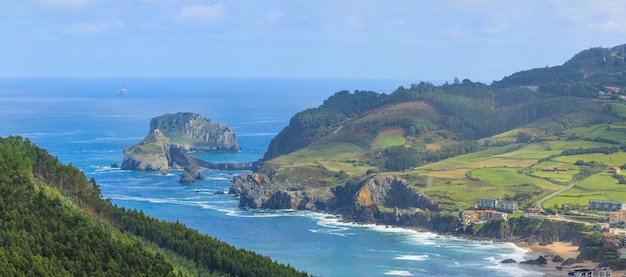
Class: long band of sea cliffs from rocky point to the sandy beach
229,173,586,240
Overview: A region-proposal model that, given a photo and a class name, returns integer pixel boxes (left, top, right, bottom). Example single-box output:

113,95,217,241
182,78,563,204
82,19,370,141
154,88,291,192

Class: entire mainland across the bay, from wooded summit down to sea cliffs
233,46,626,266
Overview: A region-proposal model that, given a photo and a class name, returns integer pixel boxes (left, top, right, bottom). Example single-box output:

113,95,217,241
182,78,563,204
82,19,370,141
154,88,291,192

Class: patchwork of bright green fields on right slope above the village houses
405,133,626,208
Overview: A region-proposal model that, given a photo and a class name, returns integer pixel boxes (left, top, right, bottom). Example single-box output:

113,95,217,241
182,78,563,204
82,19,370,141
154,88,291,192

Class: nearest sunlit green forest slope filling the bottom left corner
0,137,175,276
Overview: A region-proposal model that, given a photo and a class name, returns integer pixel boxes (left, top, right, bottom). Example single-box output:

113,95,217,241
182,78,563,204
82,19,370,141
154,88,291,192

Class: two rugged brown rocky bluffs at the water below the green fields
229,173,466,233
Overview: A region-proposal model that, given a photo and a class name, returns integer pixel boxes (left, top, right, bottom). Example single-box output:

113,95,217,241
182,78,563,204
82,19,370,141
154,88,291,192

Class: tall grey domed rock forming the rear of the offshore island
150,113,239,151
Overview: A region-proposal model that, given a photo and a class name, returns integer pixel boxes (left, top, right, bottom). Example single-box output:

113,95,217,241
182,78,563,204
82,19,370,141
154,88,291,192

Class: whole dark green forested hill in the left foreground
0,137,307,276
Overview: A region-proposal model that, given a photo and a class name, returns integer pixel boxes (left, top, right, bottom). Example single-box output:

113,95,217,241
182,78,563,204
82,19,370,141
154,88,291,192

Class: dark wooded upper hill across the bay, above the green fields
264,46,626,161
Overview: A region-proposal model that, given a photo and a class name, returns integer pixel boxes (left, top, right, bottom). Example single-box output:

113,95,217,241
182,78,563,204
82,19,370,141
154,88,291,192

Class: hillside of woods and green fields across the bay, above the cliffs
259,46,626,215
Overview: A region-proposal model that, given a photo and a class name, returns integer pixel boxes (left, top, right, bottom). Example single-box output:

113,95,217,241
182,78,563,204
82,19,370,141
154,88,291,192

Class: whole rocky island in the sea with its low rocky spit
121,113,256,183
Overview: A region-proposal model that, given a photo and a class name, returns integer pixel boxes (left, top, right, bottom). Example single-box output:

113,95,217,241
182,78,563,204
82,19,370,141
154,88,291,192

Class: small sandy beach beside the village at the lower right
516,242,624,277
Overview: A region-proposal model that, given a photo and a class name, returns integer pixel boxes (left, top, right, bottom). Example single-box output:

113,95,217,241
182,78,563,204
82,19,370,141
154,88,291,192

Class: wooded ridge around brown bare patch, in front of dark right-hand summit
264,77,578,160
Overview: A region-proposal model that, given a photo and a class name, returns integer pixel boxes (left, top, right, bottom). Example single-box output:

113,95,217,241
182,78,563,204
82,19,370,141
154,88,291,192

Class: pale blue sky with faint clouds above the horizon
0,0,626,83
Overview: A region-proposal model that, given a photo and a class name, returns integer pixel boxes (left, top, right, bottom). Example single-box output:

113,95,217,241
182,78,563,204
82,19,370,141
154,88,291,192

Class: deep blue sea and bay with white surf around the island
0,78,543,276
